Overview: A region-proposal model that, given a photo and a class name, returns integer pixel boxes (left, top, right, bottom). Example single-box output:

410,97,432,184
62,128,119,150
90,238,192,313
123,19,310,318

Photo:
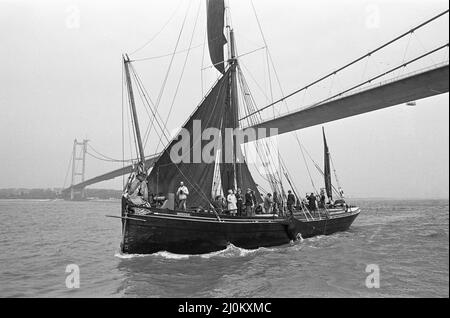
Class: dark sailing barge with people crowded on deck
116,0,360,254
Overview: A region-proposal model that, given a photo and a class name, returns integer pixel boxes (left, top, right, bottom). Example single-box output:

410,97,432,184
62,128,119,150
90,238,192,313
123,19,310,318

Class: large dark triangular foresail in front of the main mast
148,72,230,208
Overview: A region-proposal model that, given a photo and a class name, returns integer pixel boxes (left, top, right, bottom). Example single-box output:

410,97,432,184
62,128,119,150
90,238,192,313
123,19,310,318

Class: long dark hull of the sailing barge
121,209,359,254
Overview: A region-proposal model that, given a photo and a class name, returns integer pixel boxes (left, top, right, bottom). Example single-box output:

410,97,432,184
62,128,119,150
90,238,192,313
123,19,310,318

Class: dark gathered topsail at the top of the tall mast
206,0,227,74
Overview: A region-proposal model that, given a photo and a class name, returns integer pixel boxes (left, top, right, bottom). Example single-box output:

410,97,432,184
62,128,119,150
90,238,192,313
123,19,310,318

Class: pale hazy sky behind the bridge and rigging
0,0,449,198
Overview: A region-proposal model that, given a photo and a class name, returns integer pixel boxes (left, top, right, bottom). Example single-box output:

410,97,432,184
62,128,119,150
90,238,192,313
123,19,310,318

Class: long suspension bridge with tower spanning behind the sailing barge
62,10,449,199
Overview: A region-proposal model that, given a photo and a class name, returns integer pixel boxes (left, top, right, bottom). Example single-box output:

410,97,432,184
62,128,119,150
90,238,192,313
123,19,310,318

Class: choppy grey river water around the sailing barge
0,200,449,297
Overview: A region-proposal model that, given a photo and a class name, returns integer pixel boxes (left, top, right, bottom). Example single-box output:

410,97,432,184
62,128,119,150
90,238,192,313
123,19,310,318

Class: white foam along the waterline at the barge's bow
114,244,276,260
